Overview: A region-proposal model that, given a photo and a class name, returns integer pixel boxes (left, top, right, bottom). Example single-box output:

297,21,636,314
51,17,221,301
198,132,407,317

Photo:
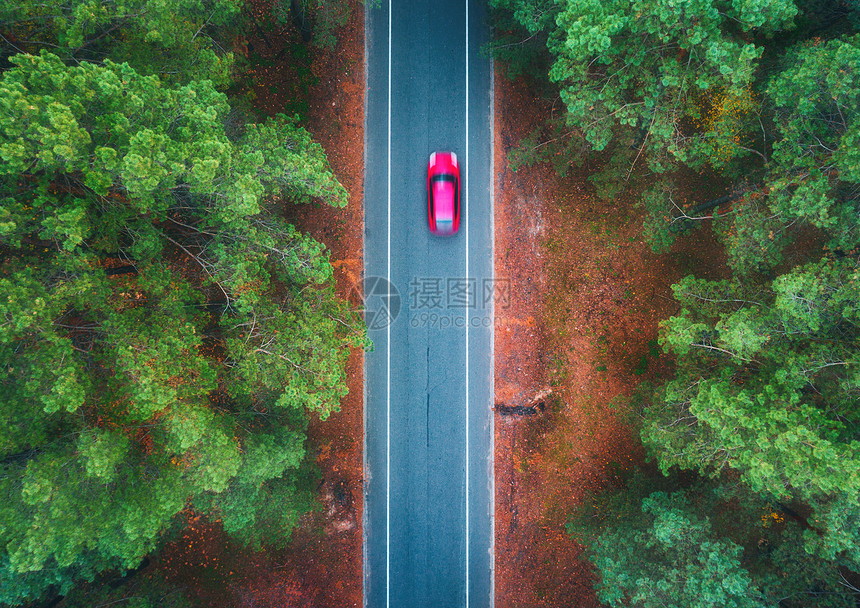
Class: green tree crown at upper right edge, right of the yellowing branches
692,36,860,273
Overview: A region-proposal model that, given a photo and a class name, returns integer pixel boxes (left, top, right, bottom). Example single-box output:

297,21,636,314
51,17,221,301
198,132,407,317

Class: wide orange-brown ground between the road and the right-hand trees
495,70,724,608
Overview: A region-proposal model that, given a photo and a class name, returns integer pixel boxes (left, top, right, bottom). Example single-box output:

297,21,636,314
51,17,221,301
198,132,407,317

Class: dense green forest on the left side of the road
0,0,369,608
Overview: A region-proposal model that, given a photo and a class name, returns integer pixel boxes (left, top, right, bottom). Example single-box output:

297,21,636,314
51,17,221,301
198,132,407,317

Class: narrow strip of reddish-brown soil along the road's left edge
272,0,364,608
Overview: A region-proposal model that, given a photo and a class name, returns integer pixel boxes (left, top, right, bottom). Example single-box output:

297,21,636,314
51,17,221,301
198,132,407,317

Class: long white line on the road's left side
385,0,391,607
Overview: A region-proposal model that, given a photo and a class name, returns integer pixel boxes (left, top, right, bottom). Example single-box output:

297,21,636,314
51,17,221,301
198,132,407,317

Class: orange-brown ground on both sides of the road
155,0,724,608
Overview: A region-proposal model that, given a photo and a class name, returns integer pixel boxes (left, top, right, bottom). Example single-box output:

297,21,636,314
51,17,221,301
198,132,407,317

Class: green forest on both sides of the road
0,0,860,608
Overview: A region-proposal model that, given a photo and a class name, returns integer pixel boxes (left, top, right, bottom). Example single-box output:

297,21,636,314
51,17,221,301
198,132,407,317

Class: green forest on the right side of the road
488,0,860,608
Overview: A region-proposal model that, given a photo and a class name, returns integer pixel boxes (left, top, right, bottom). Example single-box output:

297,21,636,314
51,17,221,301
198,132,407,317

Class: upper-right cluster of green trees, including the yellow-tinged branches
491,0,860,273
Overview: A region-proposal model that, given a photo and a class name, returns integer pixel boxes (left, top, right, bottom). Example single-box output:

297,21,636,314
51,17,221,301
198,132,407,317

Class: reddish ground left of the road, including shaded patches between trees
153,0,364,608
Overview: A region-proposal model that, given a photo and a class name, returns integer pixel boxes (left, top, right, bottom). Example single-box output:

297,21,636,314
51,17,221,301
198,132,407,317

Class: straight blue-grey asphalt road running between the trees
364,0,494,608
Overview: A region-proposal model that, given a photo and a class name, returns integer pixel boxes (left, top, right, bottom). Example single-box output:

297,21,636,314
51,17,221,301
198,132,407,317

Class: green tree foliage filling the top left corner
0,0,242,88
